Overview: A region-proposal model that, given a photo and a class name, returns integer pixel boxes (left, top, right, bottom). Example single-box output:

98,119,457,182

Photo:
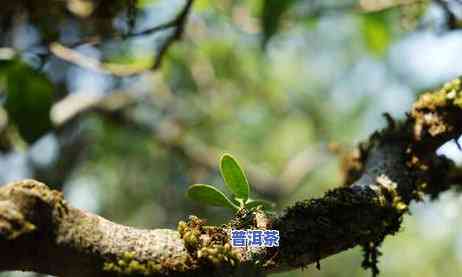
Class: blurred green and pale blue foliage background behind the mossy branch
0,0,462,277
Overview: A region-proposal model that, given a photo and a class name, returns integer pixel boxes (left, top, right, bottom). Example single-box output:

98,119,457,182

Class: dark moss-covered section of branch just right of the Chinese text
274,187,402,266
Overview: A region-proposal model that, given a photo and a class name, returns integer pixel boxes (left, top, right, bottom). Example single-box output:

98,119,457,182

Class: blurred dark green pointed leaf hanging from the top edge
261,0,295,47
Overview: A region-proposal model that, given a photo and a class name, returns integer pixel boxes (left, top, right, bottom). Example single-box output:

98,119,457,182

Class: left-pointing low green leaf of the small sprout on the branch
187,184,239,210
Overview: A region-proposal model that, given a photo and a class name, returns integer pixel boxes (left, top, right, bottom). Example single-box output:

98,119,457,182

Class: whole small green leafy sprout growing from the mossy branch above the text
187,154,272,210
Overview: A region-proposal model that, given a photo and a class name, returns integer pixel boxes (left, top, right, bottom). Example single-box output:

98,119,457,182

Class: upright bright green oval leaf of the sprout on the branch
220,154,250,202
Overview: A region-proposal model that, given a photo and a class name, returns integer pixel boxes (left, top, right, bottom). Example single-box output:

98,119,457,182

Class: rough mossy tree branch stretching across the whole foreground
0,76,462,276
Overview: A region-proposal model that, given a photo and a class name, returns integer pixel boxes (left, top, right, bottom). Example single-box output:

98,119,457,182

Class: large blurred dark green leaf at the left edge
0,59,54,143
